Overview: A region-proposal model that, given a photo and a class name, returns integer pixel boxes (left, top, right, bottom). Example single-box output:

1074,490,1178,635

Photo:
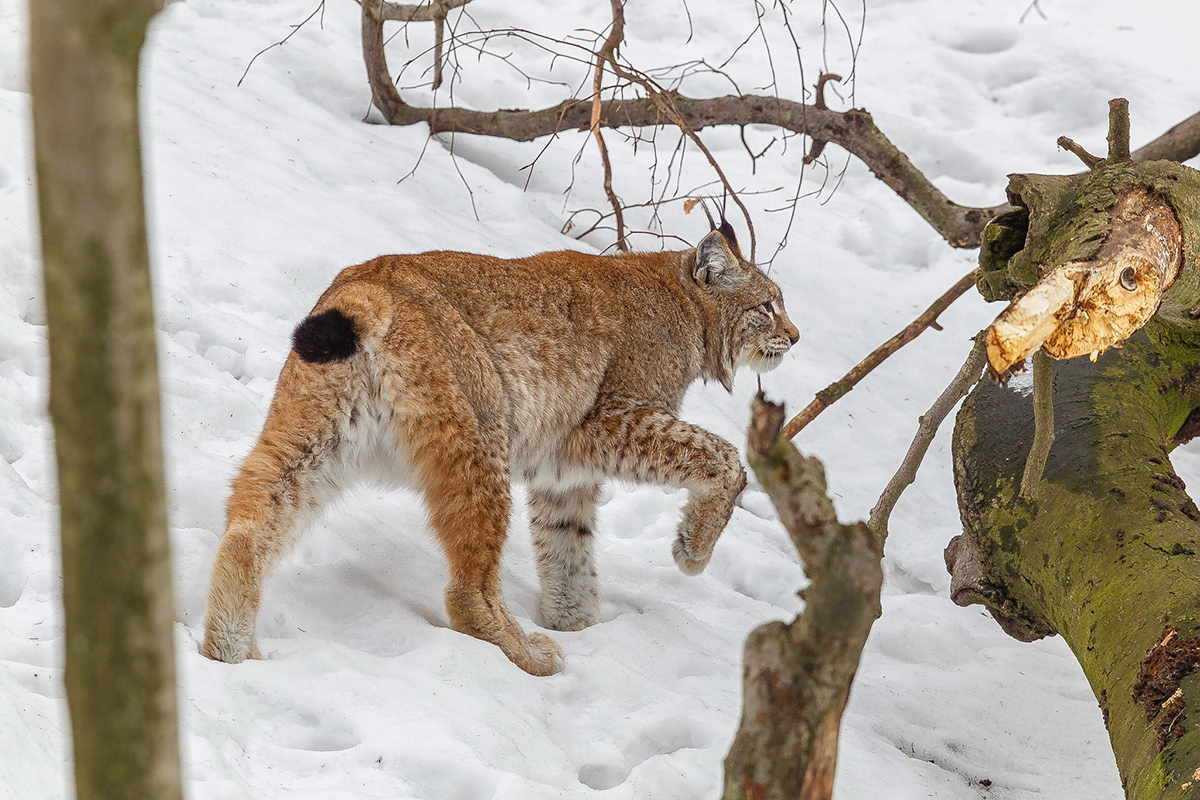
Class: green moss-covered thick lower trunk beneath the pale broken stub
954,335,1200,798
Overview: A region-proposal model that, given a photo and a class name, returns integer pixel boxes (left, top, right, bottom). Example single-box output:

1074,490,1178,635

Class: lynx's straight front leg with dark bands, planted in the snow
529,485,600,631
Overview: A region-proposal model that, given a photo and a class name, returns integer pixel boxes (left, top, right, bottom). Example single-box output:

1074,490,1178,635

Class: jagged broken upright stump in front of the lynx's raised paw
724,401,883,800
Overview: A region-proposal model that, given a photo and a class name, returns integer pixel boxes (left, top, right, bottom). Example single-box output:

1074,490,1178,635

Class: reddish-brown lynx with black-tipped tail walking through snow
203,223,799,675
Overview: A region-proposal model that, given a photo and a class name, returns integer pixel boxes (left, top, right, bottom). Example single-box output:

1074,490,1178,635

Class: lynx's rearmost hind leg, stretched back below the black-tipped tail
202,363,348,663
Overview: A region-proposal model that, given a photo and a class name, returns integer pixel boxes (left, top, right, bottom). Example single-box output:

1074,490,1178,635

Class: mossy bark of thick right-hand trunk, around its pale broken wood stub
946,162,1200,800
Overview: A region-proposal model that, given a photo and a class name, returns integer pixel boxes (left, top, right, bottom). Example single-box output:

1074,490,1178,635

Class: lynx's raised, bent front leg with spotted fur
564,409,746,575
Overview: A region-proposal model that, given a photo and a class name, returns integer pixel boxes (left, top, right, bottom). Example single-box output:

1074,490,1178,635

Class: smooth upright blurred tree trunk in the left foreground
29,0,181,800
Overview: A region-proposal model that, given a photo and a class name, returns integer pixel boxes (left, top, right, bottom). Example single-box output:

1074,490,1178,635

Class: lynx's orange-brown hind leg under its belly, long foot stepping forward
400,363,563,675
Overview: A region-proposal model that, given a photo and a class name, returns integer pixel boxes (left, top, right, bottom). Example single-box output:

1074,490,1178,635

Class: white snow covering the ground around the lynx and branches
0,0,1200,800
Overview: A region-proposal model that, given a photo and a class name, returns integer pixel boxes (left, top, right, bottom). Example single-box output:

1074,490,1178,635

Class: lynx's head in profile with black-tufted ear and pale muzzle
692,219,800,390
